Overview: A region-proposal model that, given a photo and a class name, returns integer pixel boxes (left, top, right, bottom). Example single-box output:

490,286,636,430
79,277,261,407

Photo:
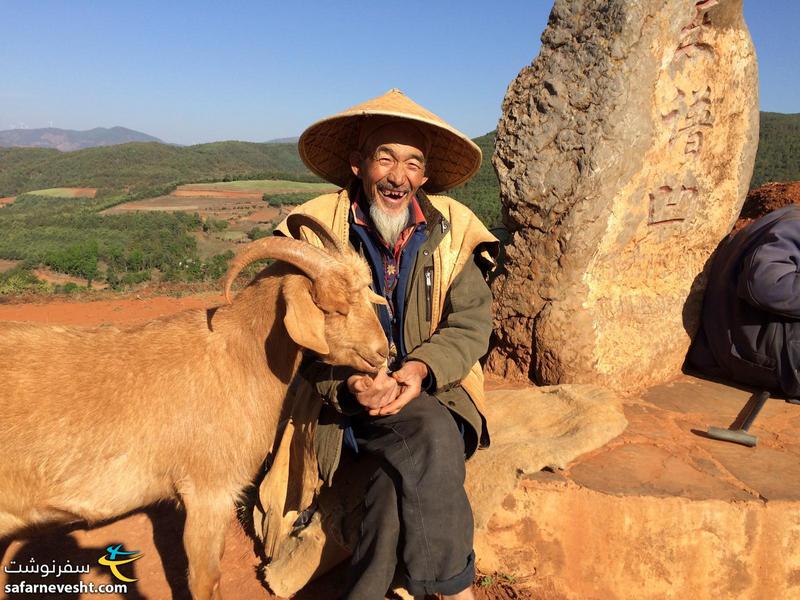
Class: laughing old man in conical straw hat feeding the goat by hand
278,90,497,600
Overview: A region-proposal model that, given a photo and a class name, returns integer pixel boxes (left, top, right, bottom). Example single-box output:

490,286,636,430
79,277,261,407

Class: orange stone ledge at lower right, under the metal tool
476,376,800,600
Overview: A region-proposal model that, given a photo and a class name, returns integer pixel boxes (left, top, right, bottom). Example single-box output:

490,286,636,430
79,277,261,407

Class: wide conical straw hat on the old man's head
297,89,481,193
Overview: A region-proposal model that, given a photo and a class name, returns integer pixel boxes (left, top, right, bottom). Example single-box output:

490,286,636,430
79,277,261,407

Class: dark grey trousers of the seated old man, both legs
345,392,475,600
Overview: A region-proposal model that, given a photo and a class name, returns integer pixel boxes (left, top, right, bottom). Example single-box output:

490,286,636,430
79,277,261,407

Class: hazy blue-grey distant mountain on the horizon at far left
0,127,164,152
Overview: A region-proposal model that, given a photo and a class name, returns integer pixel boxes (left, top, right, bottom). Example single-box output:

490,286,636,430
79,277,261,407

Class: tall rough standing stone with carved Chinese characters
489,0,758,390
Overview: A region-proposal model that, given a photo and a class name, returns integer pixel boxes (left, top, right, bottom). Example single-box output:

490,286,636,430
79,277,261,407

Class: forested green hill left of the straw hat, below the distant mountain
0,142,319,196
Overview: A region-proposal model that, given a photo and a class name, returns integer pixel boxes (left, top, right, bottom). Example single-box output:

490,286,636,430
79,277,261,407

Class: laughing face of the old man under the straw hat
350,123,428,215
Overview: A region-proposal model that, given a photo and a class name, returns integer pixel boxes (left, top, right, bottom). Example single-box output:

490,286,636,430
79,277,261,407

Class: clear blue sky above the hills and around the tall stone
0,0,800,144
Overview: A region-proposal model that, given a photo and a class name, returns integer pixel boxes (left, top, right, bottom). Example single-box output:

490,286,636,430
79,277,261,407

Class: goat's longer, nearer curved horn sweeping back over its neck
225,236,336,304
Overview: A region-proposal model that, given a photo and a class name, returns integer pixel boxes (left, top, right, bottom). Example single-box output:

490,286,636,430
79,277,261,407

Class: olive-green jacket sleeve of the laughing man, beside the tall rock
406,255,492,391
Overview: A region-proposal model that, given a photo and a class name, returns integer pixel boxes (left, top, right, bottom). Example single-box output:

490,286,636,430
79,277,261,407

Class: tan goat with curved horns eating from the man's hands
0,215,388,600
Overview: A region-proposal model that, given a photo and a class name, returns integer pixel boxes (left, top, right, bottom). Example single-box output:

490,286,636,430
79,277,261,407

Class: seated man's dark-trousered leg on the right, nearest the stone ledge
348,392,474,598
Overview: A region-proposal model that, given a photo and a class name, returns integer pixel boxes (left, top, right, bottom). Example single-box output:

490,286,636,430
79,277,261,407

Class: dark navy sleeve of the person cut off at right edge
737,221,800,319
